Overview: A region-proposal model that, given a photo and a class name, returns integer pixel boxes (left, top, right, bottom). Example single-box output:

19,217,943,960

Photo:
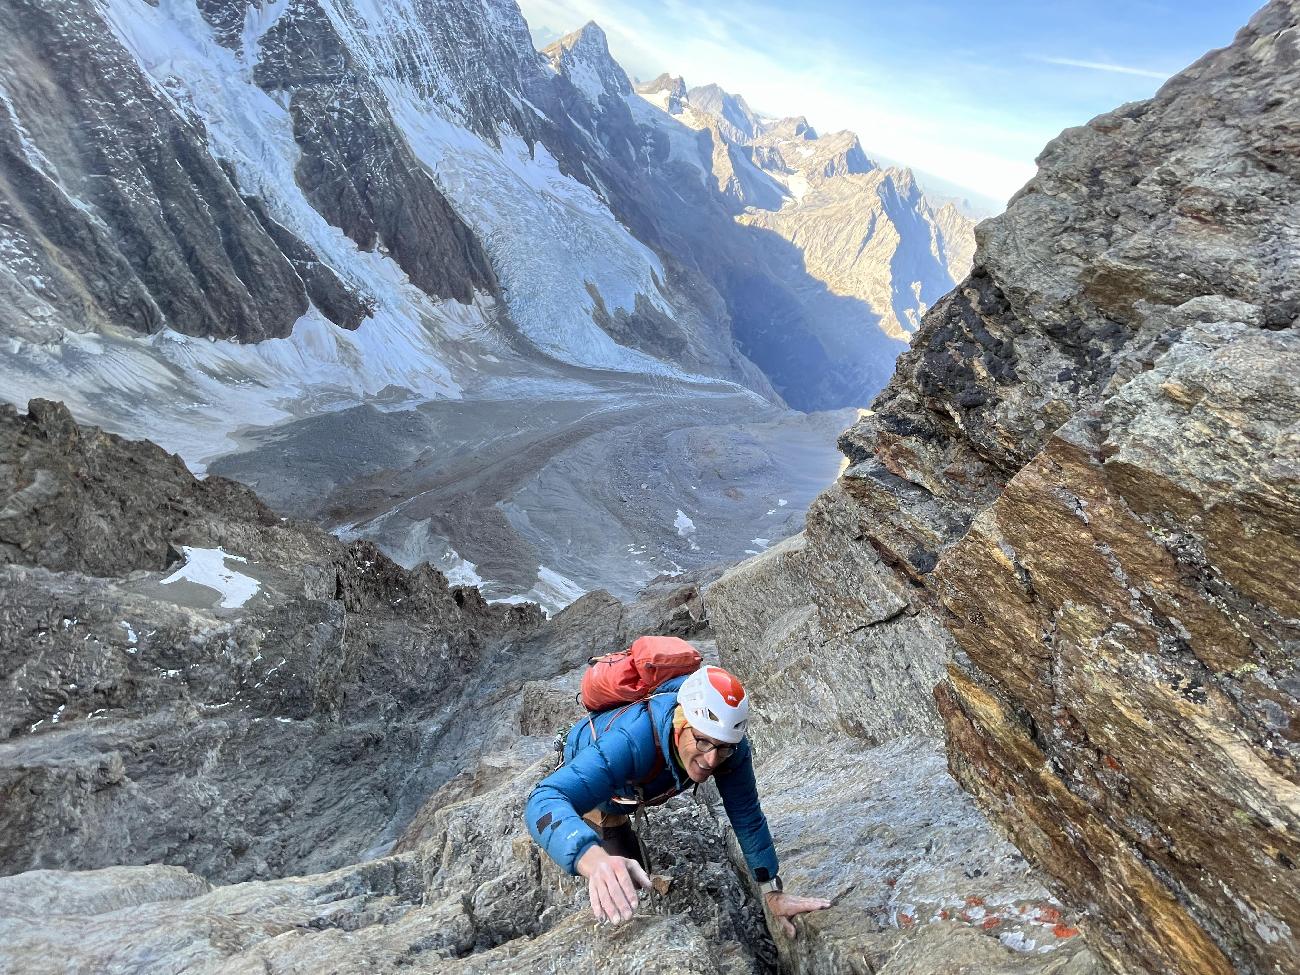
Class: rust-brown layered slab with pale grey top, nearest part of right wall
935,321,1300,972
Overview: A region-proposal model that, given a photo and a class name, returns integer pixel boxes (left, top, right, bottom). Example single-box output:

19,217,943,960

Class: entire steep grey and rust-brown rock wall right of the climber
706,3,1300,974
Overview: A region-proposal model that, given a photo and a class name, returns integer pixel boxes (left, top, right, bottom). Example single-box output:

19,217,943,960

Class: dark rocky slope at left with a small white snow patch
0,402,543,881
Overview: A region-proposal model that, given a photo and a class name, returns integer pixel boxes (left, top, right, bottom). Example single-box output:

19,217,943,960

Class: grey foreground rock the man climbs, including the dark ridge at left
0,400,1092,975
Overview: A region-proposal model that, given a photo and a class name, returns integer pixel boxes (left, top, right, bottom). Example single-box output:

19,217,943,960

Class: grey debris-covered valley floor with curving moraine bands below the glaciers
208,364,857,611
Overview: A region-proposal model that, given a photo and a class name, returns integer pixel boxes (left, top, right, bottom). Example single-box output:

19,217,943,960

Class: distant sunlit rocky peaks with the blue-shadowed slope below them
638,77,974,410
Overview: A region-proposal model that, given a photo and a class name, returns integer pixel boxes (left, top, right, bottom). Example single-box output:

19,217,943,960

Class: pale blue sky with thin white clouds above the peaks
520,0,1261,205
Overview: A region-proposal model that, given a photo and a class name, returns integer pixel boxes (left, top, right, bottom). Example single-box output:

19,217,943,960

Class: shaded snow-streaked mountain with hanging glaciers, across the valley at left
0,0,977,449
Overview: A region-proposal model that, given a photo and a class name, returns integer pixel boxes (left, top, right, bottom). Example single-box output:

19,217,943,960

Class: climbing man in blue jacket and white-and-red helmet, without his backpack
524,666,831,937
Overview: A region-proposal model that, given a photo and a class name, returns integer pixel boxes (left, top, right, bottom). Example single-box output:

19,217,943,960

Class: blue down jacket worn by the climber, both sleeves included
524,677,776,880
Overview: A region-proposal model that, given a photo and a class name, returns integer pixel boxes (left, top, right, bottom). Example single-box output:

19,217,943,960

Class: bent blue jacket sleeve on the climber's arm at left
524,728,654,875
